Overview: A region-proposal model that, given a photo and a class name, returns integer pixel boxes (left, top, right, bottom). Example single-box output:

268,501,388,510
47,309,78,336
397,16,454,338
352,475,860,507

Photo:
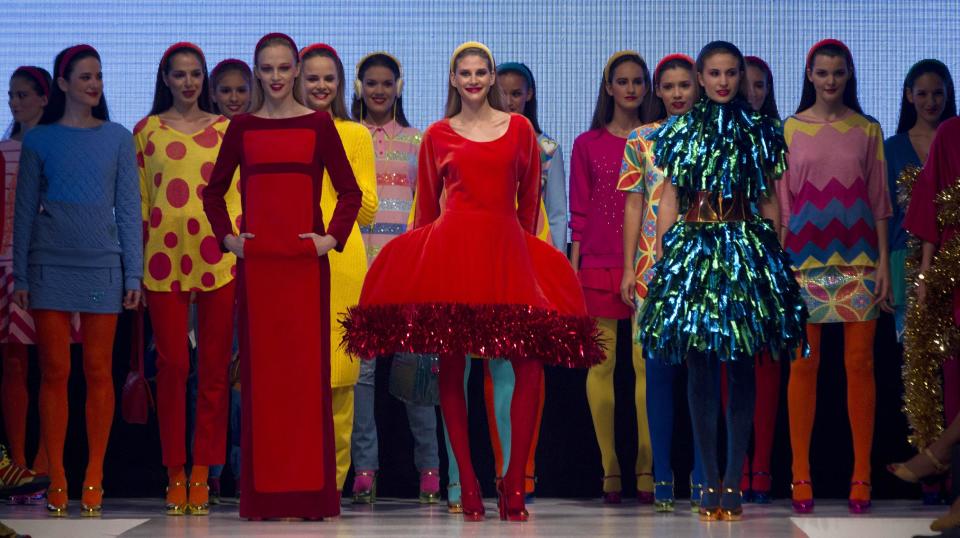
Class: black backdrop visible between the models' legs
0,308,920,499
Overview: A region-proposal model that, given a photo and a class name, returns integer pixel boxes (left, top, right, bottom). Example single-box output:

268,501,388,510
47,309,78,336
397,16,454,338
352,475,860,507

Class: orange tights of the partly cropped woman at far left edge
0,343,47,474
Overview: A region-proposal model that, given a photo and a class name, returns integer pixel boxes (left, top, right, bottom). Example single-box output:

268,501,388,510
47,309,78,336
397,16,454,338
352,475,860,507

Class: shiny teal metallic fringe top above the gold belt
651,97,787,207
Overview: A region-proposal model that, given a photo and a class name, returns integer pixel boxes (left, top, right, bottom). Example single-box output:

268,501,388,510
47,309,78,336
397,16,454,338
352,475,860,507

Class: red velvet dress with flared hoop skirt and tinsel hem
343,114,603,366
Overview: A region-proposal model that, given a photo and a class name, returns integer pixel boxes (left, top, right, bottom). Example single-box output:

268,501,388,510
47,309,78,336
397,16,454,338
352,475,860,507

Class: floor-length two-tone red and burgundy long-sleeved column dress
203,112,361,518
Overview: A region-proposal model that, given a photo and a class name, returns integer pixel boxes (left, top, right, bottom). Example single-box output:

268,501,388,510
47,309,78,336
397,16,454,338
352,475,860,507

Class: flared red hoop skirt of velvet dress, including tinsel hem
344,210,604,367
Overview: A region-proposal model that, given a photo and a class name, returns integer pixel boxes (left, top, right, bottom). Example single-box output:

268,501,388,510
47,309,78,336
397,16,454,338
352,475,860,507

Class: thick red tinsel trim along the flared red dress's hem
340,303,604,368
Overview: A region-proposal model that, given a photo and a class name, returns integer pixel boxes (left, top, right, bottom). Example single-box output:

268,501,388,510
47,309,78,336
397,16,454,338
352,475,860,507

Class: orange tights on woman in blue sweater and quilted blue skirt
33,310,117,488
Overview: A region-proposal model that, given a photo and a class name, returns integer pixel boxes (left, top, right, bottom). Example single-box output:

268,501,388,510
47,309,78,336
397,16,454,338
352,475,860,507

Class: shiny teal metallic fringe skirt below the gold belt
637,217,808,363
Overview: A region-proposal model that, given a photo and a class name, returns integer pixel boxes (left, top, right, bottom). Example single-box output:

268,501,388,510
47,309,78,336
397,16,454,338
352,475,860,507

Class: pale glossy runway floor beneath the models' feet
0,498,948,538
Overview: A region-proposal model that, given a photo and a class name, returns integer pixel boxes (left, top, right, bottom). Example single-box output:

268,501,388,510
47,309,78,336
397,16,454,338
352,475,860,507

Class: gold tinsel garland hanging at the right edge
897,167,960,450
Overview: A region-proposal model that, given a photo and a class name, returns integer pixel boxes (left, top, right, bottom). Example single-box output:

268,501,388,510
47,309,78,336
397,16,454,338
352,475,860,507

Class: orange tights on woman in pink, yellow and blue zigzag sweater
787,320,877,500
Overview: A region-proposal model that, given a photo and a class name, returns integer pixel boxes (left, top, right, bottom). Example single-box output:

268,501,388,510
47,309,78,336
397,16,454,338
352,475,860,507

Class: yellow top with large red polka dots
133,116,241,291
